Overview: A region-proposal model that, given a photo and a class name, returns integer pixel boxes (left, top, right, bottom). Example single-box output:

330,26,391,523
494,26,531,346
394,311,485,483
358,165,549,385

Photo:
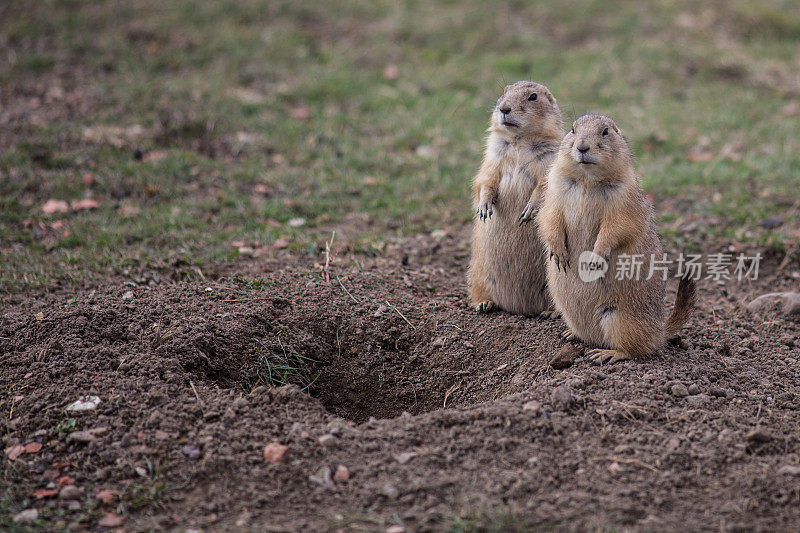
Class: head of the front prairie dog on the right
561,113,633,177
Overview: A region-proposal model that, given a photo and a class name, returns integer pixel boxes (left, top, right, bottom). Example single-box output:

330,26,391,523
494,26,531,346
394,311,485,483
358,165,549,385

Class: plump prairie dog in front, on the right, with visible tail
537,114,695,363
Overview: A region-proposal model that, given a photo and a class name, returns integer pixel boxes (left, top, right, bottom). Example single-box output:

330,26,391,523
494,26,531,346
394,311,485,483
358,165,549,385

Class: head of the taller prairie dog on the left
491,81,563,140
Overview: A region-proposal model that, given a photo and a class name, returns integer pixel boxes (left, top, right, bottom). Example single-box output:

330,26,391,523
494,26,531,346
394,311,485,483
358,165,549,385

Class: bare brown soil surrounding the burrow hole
0,228,800,531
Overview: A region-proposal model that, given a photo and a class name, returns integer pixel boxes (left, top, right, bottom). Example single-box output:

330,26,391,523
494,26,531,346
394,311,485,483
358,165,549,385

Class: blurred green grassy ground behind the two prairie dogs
0,0,800,291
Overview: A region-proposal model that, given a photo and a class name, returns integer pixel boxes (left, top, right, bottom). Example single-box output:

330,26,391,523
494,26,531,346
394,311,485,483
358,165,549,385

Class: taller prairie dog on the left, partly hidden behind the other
469,81,564,316
